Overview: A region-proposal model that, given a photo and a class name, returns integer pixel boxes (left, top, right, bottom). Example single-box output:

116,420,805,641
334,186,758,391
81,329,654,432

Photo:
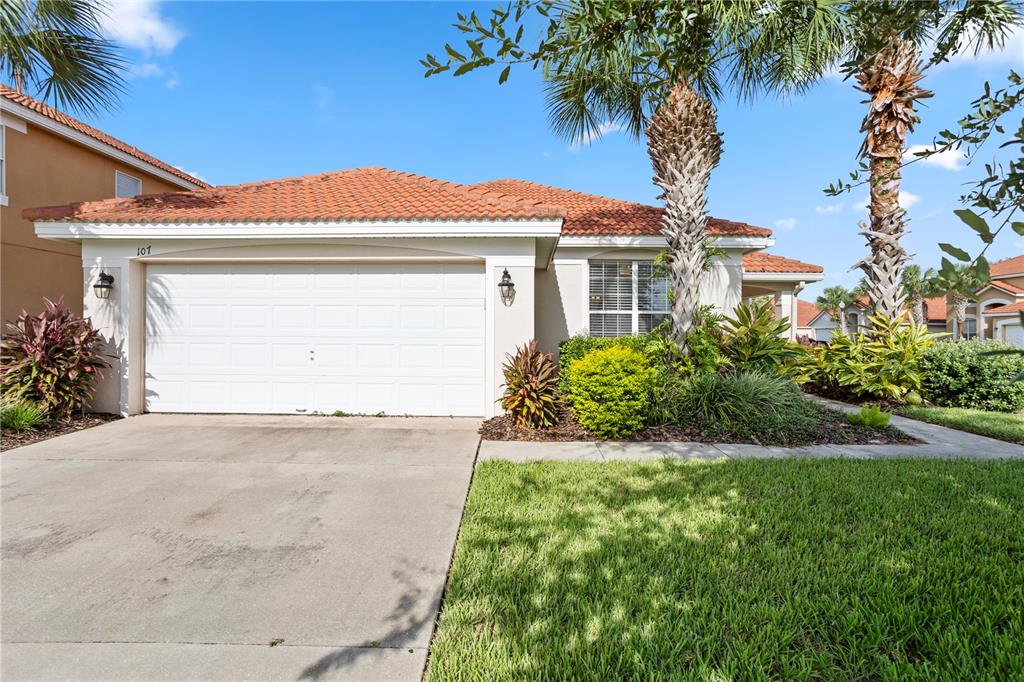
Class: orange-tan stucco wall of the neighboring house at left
0,112,182,321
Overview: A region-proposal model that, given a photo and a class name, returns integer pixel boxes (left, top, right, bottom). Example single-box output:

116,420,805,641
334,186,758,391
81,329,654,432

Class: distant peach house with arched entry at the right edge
948,250,1024,347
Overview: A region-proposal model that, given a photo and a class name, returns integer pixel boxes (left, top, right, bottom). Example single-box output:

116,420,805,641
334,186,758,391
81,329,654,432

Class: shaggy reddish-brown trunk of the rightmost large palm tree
857,34,931,319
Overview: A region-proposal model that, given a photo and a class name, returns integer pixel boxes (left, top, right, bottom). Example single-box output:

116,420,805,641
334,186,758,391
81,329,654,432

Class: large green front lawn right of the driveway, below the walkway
428,460,1024,680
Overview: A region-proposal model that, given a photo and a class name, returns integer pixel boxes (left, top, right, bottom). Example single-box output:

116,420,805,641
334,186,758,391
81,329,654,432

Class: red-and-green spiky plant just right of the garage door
501,340,558,429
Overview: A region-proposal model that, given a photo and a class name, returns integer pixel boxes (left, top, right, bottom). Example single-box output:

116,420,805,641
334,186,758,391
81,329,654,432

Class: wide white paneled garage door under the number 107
145,263,484,416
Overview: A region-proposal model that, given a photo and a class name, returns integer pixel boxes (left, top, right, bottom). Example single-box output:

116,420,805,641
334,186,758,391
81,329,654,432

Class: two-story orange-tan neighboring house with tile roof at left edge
0,84,208,321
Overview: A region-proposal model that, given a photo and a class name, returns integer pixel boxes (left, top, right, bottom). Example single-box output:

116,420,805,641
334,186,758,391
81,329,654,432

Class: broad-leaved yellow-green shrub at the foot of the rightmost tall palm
808,315,941,401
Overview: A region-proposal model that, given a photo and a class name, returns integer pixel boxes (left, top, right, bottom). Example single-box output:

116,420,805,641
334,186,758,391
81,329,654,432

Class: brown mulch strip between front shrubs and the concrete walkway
480,408,921,447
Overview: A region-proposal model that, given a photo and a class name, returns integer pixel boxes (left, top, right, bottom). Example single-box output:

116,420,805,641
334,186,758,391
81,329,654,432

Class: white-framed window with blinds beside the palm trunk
590,260,669,336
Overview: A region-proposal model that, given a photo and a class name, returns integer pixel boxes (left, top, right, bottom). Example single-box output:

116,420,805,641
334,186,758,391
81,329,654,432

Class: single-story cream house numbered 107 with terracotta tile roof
25,168,823,416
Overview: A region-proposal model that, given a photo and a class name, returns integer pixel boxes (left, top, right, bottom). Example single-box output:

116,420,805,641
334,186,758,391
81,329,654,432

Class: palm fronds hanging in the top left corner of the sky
0,0,126,114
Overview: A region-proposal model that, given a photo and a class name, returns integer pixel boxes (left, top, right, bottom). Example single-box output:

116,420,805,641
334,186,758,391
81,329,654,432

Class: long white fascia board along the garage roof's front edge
36,218,562,241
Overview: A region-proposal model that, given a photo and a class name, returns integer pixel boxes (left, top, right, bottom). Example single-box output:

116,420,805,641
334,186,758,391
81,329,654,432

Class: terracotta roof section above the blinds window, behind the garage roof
472,179,771,237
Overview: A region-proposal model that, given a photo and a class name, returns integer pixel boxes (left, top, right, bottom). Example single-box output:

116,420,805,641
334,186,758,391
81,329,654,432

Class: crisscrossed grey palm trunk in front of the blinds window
647,83,722,354
